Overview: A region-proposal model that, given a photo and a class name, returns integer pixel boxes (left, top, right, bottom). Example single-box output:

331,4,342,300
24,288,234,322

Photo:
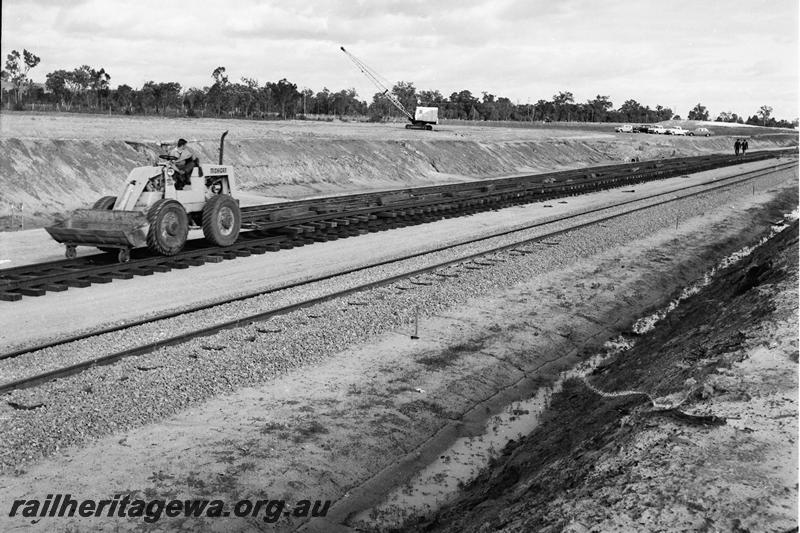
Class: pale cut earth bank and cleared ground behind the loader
0,113,798,228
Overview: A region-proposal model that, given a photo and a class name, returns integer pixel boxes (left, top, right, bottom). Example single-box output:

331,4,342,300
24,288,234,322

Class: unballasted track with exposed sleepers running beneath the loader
0,150,795,302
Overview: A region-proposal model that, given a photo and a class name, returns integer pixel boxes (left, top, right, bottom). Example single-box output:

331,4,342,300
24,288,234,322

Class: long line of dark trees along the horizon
2,50,797,128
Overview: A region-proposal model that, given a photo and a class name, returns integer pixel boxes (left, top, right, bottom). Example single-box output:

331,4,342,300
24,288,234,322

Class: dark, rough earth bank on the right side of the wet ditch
422,221,798,532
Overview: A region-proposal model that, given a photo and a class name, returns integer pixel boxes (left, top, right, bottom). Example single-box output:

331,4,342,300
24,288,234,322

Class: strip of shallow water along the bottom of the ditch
350,216,797,530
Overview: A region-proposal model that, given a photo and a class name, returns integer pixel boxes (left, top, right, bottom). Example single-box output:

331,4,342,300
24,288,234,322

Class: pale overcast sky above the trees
0,0,799,120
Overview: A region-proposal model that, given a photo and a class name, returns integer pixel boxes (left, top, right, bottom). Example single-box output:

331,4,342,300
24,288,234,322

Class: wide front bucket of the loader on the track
45,209,149,248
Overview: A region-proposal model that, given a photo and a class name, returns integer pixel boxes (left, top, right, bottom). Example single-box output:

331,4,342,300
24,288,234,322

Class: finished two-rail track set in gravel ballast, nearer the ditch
0,160,797,394
